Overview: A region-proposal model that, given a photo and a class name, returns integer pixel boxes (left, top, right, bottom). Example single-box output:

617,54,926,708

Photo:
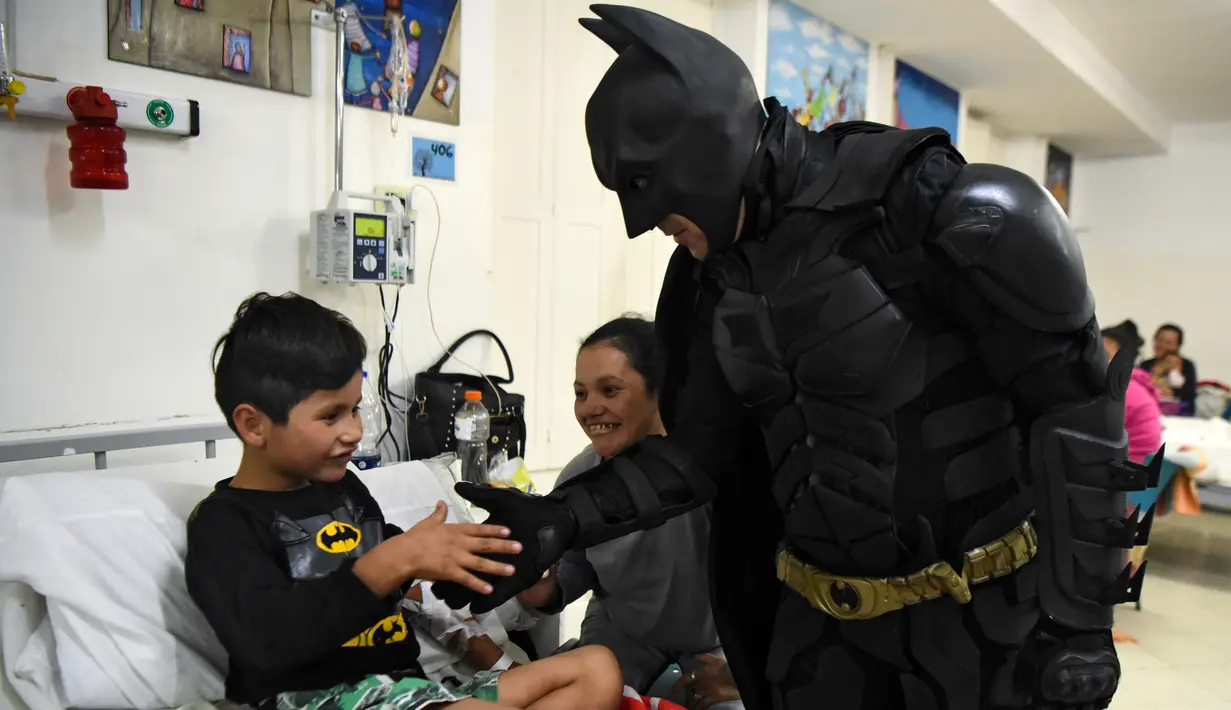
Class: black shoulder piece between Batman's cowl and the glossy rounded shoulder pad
789,122,956,212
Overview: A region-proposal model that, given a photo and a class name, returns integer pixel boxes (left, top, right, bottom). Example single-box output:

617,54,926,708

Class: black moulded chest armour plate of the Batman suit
712,206,926,426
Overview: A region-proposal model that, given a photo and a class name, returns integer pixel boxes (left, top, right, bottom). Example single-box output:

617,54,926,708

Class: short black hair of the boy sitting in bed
213,292,368,433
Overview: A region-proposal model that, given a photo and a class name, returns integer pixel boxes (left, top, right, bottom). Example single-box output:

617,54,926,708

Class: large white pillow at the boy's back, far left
0,474,225,709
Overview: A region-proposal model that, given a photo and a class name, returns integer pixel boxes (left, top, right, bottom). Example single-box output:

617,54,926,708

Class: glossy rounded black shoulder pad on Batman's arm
933,165,1094,332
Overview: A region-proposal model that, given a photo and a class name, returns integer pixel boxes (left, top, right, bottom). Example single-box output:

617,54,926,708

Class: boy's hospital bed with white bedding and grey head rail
0,420,561,710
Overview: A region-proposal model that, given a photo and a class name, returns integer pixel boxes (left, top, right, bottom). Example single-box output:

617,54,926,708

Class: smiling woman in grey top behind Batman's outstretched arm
517,315,739,705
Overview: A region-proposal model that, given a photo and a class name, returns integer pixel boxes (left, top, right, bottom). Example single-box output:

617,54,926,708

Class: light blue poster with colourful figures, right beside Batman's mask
767,0,868,130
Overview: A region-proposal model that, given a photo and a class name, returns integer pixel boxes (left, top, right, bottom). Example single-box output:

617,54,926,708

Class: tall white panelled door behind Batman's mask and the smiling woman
490,0,713,469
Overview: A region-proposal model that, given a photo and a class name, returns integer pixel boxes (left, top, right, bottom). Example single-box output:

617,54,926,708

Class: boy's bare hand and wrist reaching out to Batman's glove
353,501,522,597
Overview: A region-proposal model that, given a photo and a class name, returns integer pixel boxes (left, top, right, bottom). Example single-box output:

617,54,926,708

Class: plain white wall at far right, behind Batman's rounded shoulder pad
1072,123,1231,381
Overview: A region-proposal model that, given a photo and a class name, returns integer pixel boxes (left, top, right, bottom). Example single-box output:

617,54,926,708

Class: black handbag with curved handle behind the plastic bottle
406,330,526,461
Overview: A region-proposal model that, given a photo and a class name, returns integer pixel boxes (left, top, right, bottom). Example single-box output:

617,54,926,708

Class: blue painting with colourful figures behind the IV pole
341,0,462,126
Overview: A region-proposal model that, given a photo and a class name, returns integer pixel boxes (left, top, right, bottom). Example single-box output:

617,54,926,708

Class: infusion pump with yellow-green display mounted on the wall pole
308,191,415,285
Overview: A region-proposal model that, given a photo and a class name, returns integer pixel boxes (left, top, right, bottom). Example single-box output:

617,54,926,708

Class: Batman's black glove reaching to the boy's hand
432,484,577,614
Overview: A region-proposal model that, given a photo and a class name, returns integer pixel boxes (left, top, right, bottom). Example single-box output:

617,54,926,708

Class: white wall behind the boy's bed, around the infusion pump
0,0,495,440
